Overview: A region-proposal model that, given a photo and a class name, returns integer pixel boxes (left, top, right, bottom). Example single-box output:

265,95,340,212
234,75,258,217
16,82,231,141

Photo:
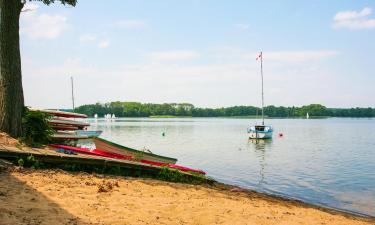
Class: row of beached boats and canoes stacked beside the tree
33,110,205,174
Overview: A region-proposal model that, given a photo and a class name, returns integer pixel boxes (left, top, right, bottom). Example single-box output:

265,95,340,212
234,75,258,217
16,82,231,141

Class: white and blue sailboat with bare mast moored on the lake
247,52,273,139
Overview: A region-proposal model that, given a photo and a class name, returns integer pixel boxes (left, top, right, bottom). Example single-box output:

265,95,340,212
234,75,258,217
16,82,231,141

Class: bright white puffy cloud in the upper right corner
333,7,375,30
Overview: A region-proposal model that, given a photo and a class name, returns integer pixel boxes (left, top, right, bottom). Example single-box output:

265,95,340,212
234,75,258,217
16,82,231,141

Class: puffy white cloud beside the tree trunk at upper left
20,3,68,39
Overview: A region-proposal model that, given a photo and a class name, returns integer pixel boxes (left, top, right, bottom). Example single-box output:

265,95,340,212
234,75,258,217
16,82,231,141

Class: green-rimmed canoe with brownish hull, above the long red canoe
93,137,177,164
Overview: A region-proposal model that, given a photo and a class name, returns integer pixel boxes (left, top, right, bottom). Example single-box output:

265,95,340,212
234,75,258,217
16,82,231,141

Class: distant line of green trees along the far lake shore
75,101,375,117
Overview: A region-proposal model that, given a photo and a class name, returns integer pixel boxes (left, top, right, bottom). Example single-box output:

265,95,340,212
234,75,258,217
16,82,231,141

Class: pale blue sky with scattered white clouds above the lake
20,0,375,108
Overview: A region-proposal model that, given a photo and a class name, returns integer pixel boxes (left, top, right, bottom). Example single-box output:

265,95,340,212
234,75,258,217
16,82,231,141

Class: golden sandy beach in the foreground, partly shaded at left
0,168,375,225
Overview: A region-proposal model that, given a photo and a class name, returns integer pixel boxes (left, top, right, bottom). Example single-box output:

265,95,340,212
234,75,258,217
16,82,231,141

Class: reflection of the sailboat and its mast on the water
248,139,272,187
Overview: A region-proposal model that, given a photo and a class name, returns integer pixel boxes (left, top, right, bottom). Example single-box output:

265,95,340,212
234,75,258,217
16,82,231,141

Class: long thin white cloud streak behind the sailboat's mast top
245,50,340,62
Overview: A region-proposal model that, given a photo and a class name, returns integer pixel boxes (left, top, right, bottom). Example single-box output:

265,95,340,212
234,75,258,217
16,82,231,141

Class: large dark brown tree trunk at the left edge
0,0,24,137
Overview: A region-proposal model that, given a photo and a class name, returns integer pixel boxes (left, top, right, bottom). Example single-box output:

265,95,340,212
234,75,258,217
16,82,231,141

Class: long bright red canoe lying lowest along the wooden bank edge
49,144,206,174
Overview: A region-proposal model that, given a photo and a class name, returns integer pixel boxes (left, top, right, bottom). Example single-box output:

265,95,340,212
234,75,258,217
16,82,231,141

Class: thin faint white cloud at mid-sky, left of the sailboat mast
146,50,199,61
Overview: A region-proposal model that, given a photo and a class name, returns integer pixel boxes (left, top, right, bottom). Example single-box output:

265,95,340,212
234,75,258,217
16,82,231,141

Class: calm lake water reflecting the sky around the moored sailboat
90,118,375,216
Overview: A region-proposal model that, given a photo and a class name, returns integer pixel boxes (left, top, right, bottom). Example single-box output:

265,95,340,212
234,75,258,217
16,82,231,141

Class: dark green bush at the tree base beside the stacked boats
22,109,53,147
